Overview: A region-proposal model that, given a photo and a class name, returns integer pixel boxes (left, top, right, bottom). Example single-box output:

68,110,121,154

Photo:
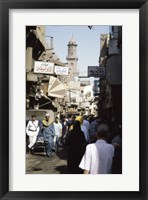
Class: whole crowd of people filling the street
26,114,122,174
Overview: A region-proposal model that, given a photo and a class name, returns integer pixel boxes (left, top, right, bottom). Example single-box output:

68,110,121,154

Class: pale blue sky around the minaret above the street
46,25,109,76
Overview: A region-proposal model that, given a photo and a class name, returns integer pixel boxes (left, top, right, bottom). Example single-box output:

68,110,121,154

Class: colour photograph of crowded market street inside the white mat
25,25,122,174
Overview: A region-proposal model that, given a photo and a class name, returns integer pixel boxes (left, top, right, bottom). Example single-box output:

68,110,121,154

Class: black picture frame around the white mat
0,0,148,200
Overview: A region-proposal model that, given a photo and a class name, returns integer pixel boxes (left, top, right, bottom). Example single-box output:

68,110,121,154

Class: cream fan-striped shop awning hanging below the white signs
48,76,65,98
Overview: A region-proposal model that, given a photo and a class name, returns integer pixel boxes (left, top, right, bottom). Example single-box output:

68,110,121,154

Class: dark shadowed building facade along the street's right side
98,26,122,123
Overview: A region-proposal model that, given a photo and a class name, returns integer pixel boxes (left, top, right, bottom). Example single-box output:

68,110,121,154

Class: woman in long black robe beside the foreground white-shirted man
66,121,86,174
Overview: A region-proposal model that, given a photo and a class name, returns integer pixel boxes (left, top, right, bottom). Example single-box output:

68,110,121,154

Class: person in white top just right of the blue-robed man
53,117,62,151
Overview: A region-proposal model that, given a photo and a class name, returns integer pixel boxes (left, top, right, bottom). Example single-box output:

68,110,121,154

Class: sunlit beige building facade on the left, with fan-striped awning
26,26,65,115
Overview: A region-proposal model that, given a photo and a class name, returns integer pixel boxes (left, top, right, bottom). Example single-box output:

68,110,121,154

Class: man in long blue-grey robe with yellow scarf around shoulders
42,113,55,157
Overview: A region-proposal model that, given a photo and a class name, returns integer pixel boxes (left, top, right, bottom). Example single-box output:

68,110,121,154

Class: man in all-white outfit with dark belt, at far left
26,115,40,151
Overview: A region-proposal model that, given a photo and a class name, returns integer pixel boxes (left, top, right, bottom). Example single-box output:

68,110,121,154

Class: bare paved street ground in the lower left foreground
26,148,67,174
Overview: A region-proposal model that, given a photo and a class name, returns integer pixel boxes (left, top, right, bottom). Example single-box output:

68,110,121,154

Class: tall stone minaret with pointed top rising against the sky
66,35,78,74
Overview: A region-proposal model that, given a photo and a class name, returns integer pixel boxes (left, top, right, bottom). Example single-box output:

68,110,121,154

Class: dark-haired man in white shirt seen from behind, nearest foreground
79,123,114,174
